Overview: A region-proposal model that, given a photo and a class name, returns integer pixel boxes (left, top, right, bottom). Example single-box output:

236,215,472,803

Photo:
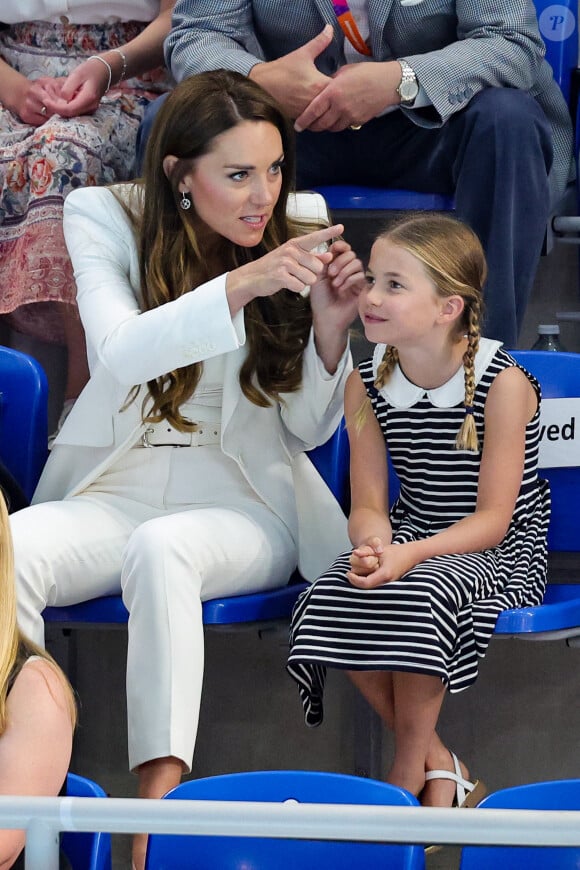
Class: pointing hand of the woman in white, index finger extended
226,224,344,316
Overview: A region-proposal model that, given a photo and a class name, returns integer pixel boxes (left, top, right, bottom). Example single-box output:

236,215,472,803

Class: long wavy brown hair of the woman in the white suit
119,70,317,431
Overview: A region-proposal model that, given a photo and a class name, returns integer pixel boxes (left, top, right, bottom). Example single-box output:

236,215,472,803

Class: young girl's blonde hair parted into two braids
368,212,487,452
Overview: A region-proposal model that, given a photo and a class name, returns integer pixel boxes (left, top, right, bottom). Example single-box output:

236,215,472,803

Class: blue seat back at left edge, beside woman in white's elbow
0,346,48,499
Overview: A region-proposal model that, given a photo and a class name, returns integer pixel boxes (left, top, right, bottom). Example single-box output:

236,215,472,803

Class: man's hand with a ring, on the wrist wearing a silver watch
294,61,401,133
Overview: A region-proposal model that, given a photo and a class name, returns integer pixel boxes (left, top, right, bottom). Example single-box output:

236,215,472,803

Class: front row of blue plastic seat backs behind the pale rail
24,770,580,870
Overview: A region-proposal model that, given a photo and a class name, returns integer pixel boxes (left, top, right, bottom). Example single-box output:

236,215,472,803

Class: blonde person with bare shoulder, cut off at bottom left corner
0,492,76,870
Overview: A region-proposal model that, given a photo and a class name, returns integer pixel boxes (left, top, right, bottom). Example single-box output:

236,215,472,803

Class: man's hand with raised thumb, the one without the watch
249,24,334,118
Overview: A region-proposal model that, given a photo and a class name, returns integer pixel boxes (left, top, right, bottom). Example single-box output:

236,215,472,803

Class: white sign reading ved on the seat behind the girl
539,399,580,468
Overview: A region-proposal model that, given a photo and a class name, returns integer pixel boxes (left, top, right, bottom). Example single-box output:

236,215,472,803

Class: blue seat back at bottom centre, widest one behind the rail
145,770,425,870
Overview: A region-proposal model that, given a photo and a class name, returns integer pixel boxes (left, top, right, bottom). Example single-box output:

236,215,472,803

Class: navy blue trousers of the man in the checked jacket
140,88,552,347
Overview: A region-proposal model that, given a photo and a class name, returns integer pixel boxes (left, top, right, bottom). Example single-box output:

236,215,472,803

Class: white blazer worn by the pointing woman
33,186,352,579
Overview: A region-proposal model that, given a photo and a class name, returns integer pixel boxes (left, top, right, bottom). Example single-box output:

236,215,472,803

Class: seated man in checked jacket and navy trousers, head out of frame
155,0,572,347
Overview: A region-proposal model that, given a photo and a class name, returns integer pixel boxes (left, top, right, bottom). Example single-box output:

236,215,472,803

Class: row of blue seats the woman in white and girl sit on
0,347,580,684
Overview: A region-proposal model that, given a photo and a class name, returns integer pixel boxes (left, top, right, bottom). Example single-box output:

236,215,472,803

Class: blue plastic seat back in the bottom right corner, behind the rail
460,779,580,870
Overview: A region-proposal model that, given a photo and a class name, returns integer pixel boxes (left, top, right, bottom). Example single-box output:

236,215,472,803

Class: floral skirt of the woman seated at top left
0,9,170,344
